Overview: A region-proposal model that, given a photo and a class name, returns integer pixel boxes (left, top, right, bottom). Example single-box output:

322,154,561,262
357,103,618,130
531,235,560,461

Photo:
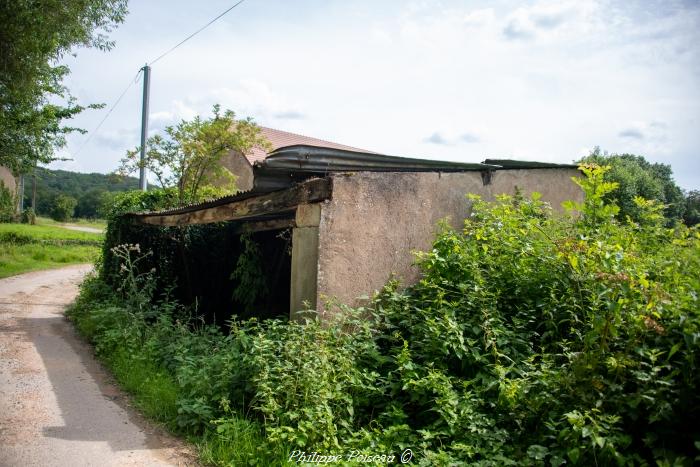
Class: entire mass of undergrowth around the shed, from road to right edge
70,166,700,466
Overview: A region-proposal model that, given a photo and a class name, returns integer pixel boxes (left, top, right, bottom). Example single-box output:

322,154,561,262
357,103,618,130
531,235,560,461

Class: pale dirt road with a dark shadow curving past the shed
0,265,195,467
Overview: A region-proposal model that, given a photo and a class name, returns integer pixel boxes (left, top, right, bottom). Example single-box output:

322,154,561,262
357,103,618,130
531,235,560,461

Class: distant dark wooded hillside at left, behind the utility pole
24,168,139,218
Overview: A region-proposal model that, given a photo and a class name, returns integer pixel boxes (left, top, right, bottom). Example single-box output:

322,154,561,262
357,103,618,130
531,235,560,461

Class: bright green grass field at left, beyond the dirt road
0,224,103,278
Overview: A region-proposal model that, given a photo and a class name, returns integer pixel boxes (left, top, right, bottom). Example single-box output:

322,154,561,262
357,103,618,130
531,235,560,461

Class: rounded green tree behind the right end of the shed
579,147,685,223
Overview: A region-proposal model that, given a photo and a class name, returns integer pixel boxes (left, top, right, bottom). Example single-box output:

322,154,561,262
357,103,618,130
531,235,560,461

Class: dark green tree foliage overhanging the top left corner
0,0,127,173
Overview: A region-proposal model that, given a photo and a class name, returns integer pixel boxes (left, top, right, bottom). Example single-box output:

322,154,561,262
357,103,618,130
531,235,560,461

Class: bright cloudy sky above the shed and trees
51,0,700,189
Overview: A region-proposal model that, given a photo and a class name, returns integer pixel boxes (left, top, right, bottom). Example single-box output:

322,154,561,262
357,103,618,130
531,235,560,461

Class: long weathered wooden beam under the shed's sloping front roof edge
134,178,332,226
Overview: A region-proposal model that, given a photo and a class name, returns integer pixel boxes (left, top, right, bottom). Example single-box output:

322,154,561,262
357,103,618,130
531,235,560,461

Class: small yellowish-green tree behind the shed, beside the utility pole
117,108,269,204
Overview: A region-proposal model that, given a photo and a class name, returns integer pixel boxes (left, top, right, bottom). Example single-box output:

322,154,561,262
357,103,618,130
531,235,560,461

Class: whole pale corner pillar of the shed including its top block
289,204,321,320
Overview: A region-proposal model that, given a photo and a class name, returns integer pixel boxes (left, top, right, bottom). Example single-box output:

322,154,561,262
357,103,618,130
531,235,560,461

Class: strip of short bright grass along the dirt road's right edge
66,288,290,466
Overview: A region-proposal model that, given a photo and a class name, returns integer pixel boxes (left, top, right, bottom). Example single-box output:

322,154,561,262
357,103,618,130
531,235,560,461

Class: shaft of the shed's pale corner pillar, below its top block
289,227,319,321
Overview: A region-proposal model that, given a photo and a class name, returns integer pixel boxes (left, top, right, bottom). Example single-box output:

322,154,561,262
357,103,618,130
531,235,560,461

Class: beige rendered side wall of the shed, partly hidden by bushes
317,169,583,310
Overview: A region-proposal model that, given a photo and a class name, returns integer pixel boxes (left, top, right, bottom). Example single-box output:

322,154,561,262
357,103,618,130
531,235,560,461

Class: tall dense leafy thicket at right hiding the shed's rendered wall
360,166,700,465
